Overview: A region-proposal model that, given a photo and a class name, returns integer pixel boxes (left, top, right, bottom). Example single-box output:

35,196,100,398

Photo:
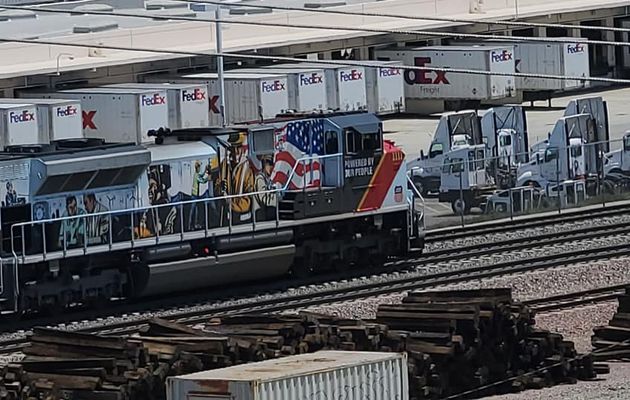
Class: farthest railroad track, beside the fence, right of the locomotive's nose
425,202,630,243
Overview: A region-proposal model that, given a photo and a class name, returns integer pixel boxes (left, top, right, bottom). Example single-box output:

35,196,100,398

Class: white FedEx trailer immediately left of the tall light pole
105,83,210,129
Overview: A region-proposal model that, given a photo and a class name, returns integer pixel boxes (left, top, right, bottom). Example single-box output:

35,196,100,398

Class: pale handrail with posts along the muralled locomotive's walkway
11,153,343,261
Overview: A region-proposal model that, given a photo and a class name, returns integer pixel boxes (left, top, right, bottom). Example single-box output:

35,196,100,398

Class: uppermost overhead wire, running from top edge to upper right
175,0,630,32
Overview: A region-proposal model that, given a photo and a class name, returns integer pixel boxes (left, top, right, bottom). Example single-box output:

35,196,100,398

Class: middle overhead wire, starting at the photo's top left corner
0,5,630,46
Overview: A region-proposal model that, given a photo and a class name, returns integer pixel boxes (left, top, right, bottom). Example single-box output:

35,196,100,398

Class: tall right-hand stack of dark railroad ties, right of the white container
377,289,596,399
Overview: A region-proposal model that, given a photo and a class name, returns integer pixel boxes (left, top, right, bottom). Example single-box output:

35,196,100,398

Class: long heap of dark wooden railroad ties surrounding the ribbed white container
0,289,595,400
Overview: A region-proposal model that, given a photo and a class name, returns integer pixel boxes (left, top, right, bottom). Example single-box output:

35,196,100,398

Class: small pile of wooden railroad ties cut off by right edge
591,286,630,361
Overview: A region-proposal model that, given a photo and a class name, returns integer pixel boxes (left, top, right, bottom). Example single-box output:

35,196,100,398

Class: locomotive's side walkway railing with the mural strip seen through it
11,153,343,265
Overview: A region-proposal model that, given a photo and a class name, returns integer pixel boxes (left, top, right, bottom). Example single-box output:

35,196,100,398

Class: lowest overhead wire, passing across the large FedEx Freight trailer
0,38,630,85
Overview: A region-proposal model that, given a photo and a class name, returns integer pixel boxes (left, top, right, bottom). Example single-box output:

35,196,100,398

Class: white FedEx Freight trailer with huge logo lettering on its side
375,46,515,102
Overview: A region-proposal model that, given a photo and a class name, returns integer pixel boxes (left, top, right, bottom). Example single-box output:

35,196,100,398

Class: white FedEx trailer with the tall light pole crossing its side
167,72,289,125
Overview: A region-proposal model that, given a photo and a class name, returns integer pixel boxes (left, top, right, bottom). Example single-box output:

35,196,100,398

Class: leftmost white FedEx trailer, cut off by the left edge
0,104,50,149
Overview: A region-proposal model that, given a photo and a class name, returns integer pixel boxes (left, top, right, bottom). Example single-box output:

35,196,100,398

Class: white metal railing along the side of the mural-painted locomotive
11,153,343,263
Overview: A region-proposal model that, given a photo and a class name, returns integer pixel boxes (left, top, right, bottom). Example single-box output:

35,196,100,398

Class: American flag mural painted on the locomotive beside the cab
271,120,324,189
